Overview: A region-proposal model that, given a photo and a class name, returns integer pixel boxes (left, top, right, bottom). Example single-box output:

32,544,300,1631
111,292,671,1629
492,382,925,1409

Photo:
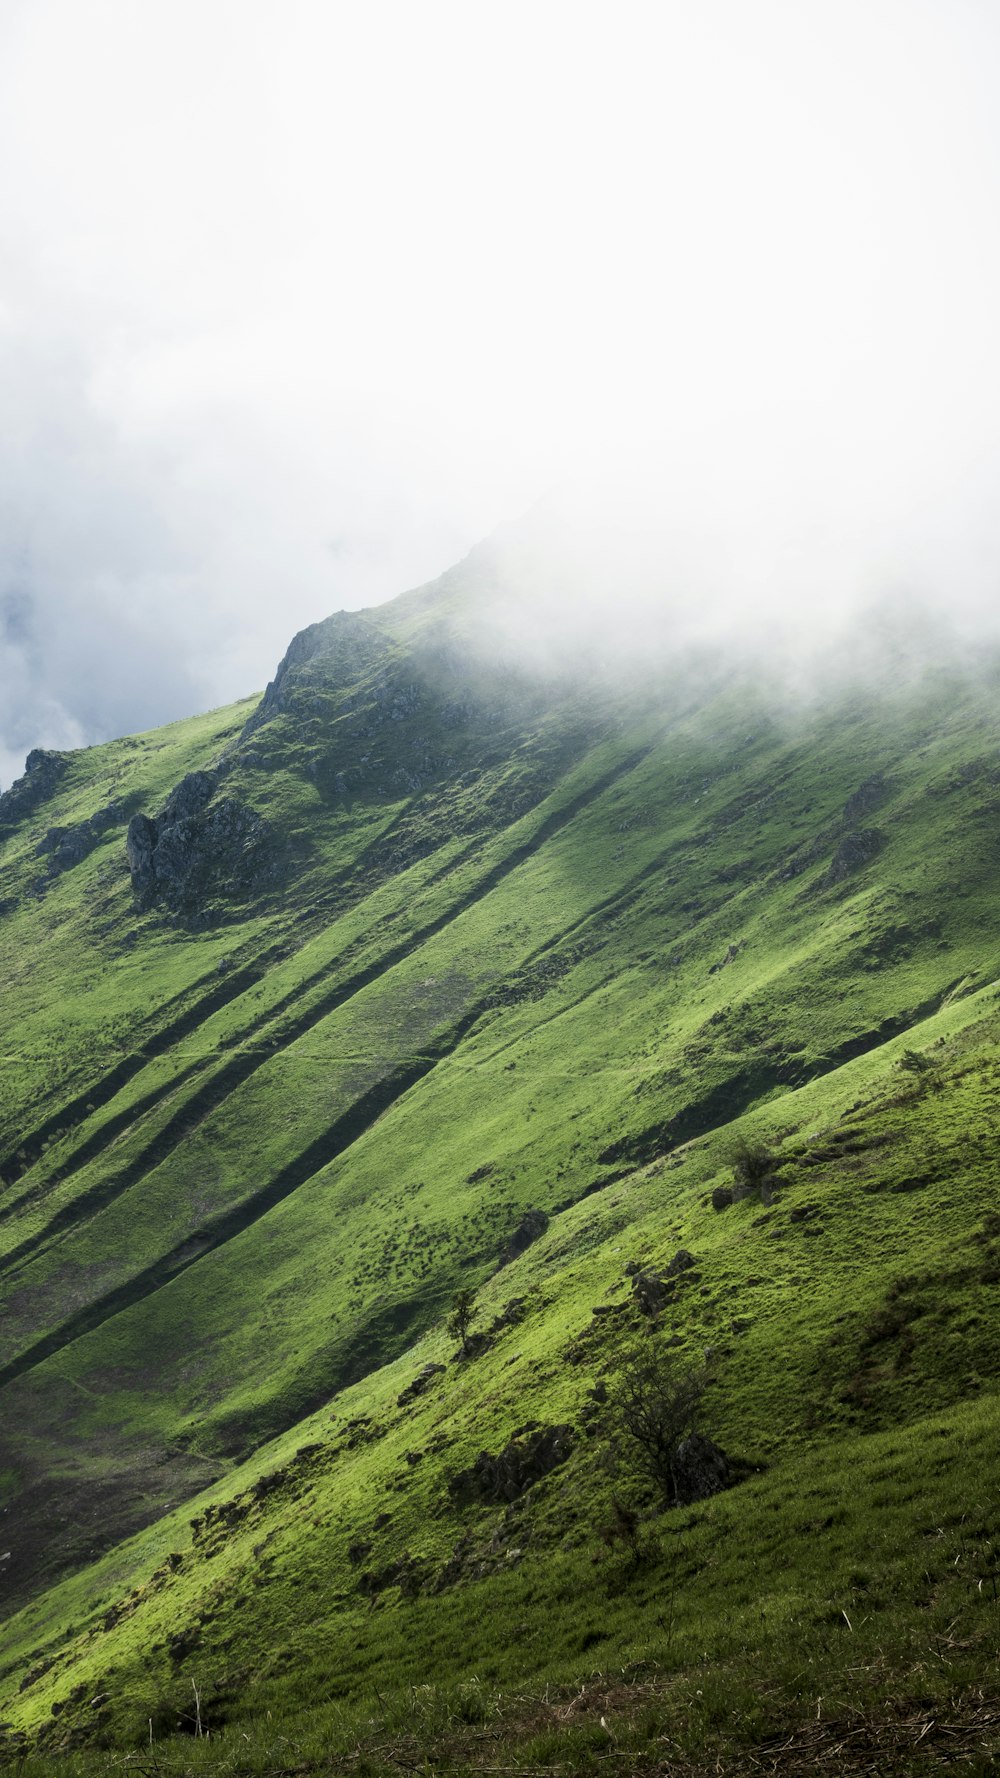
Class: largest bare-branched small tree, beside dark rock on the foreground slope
612,1344,708,1506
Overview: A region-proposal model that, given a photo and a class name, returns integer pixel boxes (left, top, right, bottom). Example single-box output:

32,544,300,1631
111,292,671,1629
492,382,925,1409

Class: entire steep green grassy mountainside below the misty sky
0,546,1000,1773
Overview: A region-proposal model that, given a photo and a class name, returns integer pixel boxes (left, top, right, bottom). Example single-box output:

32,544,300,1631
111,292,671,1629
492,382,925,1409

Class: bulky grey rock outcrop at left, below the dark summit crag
125,772,276,921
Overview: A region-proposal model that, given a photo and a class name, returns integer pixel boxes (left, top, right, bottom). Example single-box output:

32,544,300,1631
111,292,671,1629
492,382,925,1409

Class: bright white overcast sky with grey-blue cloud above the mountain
0,0,1000,784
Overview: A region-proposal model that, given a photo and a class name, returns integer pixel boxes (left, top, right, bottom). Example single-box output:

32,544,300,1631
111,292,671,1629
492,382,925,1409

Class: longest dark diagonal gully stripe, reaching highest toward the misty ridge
0,747,651,1280
